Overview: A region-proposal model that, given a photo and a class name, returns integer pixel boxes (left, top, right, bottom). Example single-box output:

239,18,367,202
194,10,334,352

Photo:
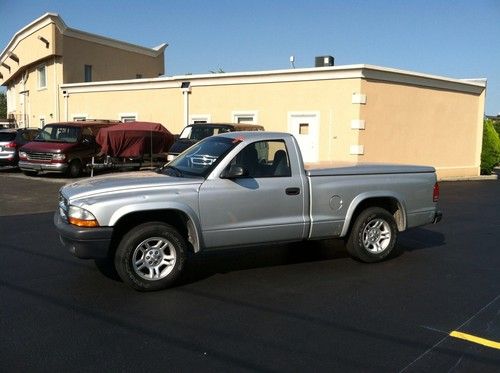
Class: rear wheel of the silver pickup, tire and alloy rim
346,207,399,263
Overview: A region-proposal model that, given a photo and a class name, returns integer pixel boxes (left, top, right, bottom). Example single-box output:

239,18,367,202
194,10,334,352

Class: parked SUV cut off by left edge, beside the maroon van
0,128,40,167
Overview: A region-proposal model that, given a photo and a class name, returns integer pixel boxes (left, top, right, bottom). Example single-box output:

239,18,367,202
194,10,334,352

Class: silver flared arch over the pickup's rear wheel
340,192,406,237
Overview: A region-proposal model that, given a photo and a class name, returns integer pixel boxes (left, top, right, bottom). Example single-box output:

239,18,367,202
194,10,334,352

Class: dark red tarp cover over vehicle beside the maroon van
96,122,174,157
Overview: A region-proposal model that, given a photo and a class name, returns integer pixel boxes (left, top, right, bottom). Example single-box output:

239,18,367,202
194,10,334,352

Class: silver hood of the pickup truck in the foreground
61,171,204,199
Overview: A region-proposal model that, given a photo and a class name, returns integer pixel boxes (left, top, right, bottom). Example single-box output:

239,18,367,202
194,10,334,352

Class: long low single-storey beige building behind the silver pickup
2,13,486,178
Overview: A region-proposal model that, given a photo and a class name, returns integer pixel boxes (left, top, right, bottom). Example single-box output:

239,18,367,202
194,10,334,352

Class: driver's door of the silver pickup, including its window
199,140,306,247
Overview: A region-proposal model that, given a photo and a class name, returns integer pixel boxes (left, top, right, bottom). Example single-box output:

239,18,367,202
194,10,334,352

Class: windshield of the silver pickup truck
160,137,239,177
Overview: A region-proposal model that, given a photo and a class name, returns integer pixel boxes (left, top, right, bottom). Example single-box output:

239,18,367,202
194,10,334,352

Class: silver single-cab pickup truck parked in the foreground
54,132,441,291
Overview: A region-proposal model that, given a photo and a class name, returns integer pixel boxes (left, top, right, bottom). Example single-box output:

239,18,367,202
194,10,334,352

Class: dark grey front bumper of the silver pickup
54,211,113,259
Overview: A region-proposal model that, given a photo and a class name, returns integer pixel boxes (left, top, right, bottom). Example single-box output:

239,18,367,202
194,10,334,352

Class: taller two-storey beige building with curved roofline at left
0,13,167,126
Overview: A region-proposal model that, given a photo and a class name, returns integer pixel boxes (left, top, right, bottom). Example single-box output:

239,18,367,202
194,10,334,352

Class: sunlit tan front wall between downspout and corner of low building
190,79,360,160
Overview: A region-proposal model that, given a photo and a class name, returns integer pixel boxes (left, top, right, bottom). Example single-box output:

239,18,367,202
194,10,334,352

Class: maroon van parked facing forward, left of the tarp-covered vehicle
19,120,121,177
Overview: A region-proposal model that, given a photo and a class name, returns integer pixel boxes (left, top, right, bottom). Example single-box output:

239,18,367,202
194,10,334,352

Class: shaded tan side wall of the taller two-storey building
63,36,164,83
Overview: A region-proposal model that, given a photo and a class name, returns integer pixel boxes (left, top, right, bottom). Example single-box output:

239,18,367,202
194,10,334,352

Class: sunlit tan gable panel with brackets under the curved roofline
0,23,56,84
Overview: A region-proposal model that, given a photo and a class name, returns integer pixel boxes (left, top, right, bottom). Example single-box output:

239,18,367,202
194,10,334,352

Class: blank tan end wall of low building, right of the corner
359,81,484,176
